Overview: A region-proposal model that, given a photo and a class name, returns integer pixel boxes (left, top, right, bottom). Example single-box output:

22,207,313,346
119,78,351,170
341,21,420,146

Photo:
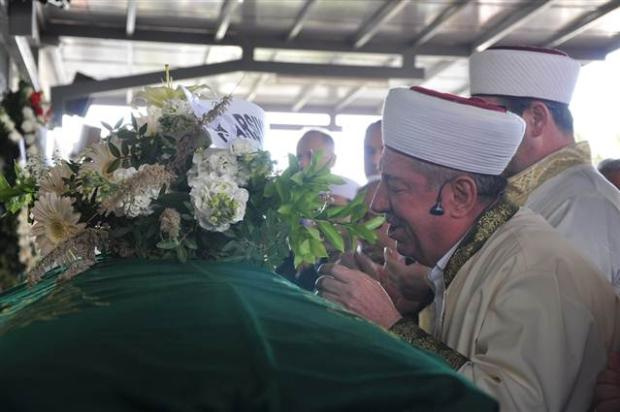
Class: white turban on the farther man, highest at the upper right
469,47,580,104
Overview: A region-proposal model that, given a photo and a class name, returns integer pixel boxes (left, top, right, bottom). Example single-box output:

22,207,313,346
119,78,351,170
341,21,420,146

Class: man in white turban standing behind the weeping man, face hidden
469,47,620,293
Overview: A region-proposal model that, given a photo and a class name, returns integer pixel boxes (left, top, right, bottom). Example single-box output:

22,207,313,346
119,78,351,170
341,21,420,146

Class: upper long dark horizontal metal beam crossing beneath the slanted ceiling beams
42,21,607,60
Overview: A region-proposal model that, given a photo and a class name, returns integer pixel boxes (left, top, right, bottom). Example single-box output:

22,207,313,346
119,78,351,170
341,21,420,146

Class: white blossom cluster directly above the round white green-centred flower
187,149,239,186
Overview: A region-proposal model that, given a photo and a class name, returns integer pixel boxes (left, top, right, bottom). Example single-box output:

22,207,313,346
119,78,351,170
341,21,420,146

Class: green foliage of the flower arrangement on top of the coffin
0,79,383,278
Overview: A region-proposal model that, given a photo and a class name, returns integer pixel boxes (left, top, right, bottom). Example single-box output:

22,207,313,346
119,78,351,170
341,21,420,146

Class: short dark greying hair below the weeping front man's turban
413,159,508,199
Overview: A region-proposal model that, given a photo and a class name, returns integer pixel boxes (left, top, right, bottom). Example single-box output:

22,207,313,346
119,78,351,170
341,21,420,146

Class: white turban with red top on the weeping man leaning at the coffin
383,87,525,175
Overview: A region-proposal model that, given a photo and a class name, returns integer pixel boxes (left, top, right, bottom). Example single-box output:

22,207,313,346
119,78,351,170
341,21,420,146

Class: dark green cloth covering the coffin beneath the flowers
0,260,497,412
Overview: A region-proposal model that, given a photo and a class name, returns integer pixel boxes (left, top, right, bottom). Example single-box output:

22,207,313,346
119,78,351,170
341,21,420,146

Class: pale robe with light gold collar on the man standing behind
508,142,620,293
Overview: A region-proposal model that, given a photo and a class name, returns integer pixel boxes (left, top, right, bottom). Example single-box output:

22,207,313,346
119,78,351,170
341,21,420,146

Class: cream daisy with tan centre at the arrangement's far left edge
32,193,86,255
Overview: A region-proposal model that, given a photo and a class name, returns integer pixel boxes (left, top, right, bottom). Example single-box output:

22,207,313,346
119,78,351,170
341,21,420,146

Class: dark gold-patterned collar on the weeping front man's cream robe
444,198,519,290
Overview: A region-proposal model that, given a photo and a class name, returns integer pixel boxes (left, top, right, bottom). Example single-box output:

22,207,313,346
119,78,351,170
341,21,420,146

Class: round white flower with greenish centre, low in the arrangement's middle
189,176,249,232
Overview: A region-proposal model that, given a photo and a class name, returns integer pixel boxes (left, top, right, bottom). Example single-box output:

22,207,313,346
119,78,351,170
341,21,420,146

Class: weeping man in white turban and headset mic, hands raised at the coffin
316,88,620,411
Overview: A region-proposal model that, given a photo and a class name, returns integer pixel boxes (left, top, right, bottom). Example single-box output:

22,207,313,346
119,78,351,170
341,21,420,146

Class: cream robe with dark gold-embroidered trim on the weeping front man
391,202,620,411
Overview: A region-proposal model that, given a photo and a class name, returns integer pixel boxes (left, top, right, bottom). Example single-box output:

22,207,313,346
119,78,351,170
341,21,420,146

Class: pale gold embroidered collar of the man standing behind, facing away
507,142,591,206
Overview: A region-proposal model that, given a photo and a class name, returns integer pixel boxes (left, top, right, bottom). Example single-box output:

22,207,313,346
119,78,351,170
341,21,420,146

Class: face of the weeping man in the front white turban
371,148,443,267
